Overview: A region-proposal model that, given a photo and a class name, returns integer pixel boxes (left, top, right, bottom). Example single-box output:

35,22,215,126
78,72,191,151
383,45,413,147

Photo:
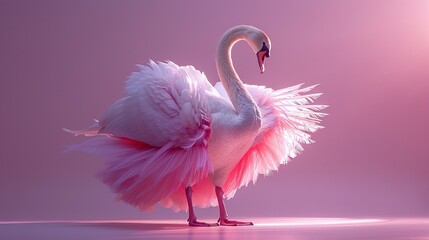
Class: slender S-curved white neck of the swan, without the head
216,26,260,118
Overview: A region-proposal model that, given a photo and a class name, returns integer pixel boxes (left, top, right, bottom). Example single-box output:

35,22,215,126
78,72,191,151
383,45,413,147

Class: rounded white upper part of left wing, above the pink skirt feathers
100,61,211,148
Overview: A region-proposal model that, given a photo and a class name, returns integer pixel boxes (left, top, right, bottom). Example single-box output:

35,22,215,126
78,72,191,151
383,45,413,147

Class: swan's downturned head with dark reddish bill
244,28,271,73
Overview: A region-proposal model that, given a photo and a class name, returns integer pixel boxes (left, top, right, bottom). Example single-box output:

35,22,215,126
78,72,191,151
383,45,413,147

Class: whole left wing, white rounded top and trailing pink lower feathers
66,61,213,210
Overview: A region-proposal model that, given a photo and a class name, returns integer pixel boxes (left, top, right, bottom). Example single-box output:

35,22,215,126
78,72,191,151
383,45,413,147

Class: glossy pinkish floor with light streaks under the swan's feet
0,218,429,240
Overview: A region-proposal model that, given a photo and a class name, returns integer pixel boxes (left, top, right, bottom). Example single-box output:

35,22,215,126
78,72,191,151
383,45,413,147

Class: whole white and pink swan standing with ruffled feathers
65,25,326,226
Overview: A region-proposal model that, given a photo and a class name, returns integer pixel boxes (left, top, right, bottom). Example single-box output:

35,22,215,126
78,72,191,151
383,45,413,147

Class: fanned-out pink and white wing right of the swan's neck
215,83,326,198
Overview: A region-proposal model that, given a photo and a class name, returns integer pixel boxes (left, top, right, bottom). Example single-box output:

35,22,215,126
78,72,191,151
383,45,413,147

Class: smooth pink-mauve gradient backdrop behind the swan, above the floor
0,0,429,220
